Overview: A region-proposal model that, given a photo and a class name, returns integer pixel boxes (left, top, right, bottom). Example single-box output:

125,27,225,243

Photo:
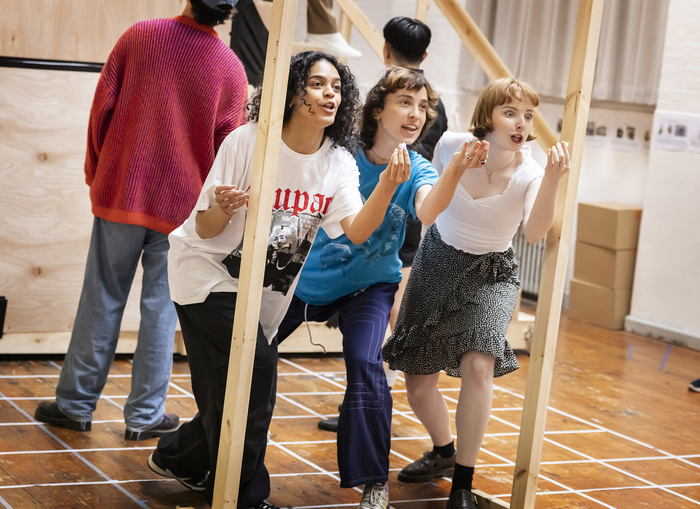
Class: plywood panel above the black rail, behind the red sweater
0,0,231,62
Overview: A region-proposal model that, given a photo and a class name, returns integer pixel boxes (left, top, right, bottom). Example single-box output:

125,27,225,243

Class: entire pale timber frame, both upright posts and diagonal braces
212,0,603,509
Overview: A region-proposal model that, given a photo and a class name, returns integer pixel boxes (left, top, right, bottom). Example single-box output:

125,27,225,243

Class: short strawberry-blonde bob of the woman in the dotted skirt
469,78,540,141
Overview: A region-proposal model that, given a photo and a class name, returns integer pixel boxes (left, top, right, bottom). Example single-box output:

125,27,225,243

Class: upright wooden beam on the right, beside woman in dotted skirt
510,0,603,509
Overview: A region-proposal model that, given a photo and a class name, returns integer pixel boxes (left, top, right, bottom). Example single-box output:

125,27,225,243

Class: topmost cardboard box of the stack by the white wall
576,202,642,249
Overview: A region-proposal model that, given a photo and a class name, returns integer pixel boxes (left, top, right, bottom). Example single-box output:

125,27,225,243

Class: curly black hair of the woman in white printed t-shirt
248,51,362,153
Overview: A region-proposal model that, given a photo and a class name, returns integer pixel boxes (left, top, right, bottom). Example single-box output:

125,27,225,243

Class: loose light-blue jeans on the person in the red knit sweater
56,217,177,431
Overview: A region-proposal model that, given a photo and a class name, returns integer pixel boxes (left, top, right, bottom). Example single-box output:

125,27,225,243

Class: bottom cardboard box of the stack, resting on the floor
569,279,632,330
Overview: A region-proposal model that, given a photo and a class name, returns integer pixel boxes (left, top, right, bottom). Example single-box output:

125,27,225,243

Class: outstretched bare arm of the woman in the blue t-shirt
413,141,489,224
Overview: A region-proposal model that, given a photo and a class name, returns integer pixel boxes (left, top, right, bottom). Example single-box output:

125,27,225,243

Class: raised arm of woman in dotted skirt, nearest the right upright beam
523,142,571,244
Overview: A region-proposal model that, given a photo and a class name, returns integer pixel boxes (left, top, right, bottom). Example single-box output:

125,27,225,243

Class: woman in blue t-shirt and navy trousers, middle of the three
277,67,488,508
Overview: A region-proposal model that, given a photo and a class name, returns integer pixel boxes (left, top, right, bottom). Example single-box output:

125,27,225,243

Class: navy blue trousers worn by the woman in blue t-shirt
277,283,399,488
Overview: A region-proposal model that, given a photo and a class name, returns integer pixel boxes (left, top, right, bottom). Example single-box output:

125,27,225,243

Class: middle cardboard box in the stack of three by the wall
574,241,637,290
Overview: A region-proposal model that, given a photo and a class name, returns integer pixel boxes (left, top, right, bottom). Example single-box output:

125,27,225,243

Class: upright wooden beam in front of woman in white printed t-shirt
212,0,297,509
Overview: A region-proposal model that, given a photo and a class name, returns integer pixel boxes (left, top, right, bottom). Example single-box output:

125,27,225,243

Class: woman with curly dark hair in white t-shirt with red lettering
149,52,409,508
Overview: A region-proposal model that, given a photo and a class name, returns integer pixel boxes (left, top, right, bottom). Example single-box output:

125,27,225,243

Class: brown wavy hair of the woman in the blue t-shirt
360,66,438,150
